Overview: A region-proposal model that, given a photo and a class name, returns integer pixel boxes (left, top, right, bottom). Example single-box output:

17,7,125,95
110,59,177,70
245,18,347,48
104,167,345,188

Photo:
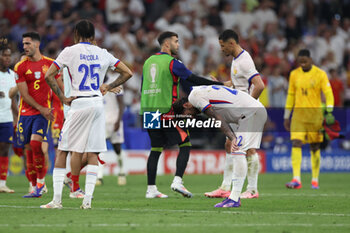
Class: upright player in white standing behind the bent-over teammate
204,30,264,198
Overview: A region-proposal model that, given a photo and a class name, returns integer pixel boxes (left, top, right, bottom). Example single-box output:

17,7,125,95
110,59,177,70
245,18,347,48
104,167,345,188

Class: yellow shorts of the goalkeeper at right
290,120,323,144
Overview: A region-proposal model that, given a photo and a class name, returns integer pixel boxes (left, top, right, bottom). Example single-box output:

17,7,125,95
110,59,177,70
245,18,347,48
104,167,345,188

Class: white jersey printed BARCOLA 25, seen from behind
54,42,120,96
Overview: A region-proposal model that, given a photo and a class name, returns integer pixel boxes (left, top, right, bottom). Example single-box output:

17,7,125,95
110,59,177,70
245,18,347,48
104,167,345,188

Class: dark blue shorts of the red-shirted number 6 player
16,114,49,146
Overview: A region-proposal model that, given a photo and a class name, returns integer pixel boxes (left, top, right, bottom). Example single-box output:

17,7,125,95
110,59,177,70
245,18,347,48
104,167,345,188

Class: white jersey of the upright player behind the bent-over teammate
231,50,259,94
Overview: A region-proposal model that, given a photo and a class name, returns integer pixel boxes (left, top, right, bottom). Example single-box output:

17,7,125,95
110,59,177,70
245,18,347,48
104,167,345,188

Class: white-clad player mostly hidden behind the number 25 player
96,72,126,185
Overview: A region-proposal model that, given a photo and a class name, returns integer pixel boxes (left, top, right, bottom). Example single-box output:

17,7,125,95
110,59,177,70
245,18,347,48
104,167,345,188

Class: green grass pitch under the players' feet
0,173,350,233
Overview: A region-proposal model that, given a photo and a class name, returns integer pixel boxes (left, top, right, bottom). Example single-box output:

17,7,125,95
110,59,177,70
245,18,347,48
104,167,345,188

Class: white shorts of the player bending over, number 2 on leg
230,108,267,154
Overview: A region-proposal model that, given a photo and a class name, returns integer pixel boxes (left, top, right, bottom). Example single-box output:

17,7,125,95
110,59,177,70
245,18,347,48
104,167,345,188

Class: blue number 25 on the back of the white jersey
78,64,101,91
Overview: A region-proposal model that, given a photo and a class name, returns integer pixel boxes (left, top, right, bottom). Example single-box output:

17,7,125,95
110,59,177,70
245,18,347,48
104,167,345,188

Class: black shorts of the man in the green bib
147,127,190,147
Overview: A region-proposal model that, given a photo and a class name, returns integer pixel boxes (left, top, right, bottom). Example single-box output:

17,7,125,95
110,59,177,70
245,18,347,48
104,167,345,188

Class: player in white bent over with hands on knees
173,86,267,207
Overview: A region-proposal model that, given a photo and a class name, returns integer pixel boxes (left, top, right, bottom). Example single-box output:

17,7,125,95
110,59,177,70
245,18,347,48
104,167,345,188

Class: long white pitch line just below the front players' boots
0,205,350,217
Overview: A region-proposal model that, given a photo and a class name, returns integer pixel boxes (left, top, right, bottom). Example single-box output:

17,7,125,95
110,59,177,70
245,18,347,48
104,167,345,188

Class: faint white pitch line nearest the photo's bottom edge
0,223,350,228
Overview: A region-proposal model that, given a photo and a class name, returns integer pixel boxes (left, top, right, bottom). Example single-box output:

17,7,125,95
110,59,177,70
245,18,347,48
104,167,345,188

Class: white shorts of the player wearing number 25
58,97,107,153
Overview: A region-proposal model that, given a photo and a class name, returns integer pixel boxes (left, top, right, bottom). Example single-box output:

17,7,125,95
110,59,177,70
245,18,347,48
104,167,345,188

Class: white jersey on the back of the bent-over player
188,85,264,123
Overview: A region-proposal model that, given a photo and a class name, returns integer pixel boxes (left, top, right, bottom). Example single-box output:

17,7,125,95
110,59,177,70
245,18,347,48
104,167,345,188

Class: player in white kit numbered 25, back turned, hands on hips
40,20,132,209
